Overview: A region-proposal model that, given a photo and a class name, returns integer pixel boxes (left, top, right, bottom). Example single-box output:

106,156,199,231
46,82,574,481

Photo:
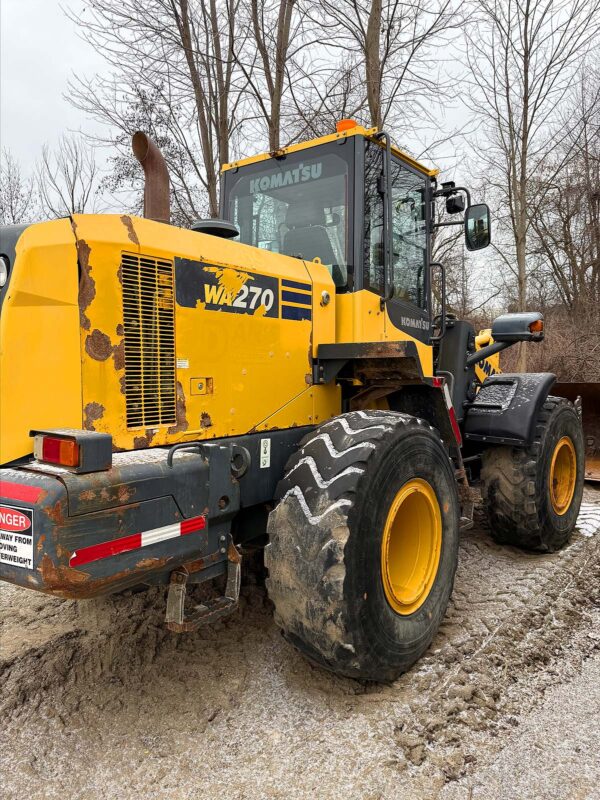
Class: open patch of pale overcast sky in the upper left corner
0,0,104,169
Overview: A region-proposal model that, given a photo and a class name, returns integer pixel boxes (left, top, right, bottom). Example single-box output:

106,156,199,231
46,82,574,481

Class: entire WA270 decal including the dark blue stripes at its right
175,258,312,320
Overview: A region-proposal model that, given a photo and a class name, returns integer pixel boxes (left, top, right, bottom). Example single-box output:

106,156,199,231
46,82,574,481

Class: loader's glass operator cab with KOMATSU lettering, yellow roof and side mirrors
221,120,489,342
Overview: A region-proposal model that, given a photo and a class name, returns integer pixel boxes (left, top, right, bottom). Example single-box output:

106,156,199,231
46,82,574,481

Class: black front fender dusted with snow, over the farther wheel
464,372,556,447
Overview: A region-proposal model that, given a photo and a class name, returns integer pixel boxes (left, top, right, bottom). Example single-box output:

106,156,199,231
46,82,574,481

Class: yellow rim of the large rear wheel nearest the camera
381,478,442,615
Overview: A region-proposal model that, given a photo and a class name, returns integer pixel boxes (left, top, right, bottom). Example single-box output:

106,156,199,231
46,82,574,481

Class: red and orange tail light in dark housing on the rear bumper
29,429,112,472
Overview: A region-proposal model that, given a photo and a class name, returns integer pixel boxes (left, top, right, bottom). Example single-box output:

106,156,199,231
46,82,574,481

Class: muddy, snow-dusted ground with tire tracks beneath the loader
0,488,600,800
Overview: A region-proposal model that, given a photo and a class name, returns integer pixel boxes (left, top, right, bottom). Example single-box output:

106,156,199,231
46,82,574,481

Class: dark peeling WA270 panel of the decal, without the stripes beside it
175,258,279,317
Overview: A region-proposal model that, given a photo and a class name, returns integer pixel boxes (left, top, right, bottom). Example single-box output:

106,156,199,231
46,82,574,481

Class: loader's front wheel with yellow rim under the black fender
481,397,585,553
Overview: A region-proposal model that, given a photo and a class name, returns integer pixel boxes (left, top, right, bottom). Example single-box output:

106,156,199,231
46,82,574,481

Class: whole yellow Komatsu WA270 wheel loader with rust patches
0,120,584,681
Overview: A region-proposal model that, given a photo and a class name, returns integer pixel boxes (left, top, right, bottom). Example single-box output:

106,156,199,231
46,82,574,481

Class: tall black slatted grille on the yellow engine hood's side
121,253,176,428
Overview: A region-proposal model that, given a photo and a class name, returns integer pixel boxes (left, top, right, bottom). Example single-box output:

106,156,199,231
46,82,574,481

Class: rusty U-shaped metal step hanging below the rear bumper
165,534,242,633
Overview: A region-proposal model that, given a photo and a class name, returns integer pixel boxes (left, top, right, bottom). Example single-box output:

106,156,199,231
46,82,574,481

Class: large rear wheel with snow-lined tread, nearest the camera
265,411,459,680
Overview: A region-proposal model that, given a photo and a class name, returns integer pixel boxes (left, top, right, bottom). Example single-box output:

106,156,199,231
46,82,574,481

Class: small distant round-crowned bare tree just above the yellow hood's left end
36,135,99,217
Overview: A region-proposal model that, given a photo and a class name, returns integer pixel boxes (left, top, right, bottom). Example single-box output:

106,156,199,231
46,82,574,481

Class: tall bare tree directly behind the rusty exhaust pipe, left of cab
69,0,244,216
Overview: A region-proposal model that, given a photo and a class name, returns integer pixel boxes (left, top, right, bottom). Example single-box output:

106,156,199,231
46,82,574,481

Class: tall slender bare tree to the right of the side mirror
465,0,600,371
